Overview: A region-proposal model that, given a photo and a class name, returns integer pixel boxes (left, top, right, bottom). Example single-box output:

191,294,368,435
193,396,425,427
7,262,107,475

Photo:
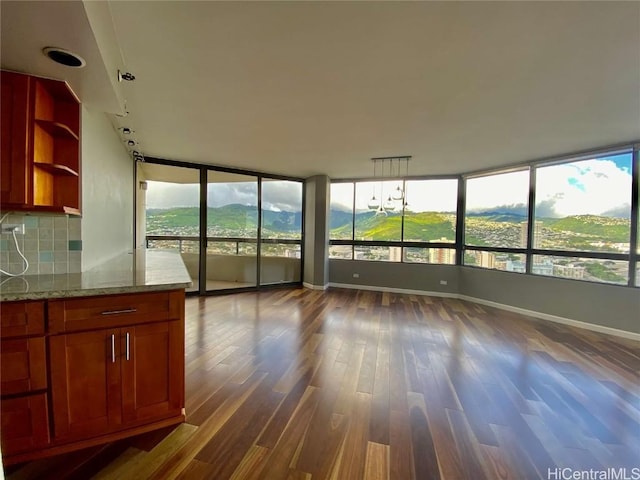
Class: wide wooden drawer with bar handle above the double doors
49,291,182,333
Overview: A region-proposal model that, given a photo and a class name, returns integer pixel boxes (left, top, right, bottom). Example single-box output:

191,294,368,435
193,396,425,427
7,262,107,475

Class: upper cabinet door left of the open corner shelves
0,72,32,206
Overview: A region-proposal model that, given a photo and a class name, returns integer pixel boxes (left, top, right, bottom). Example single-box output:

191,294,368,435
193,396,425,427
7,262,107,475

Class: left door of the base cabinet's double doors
49,329,122,440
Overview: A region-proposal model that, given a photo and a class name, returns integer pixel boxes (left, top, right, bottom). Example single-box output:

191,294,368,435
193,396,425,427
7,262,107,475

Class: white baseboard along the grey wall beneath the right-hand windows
329,282,640,341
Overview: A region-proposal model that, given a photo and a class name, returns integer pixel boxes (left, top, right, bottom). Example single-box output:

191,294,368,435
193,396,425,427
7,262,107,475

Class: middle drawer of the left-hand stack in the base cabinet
0,337,47,395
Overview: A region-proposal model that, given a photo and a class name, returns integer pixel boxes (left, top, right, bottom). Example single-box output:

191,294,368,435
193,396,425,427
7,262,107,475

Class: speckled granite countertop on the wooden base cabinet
0,249,191,301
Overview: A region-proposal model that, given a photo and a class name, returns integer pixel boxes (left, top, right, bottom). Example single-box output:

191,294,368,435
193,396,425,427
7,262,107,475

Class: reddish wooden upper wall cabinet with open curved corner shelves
0,72,81,214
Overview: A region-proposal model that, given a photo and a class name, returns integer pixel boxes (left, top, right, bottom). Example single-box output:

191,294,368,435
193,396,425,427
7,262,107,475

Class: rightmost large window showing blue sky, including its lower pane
532,152,632,285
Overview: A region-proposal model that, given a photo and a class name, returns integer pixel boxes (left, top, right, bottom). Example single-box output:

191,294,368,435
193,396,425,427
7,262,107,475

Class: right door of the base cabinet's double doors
120,320,184,423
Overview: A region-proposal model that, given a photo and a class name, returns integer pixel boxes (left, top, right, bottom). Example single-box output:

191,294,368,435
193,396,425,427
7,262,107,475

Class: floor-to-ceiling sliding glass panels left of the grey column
137,159,304,294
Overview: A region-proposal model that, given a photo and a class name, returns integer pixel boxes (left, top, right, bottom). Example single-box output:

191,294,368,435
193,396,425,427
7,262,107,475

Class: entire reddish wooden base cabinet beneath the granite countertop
1,290,184,464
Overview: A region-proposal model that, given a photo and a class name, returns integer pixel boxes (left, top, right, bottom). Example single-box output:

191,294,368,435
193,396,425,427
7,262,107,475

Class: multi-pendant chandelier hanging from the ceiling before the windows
367,155,411,215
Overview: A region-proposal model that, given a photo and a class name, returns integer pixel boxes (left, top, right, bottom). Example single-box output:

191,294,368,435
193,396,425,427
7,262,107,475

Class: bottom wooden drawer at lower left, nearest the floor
0,393,50,455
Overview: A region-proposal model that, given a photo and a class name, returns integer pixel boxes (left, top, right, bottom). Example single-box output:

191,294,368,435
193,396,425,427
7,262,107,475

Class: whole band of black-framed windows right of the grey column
329,146,640,287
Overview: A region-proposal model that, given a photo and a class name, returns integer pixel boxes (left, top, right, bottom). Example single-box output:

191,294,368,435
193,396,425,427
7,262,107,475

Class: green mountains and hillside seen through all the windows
147,204,630,251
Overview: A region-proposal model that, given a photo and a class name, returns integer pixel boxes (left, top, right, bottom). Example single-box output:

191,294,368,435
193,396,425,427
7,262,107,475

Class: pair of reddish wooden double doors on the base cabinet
50,321,184,440
